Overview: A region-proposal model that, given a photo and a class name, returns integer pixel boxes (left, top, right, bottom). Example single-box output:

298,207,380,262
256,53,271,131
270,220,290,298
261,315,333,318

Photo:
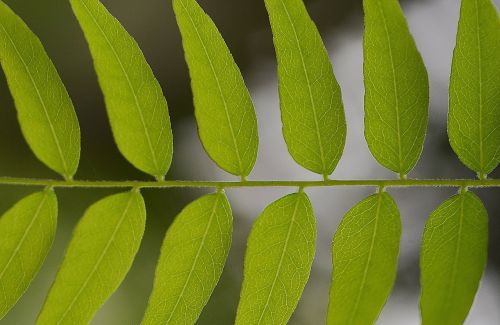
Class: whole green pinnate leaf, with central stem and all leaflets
0,0,500,325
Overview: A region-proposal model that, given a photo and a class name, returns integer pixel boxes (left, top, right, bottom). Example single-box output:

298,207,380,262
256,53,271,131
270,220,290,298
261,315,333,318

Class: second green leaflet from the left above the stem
71,0,173,179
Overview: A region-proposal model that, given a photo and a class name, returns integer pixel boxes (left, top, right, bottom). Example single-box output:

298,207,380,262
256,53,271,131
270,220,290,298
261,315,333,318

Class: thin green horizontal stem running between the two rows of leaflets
0,177,500,188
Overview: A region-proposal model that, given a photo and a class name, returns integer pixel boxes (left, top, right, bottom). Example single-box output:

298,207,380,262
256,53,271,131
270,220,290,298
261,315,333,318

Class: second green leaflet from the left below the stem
37,191,146,325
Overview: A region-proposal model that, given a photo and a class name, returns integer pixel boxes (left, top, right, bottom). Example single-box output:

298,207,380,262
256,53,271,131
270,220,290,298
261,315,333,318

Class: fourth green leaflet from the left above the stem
265,0,346,177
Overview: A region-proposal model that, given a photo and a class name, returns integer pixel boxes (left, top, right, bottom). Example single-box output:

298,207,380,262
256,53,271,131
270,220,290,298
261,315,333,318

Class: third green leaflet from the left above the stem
173,0,259,177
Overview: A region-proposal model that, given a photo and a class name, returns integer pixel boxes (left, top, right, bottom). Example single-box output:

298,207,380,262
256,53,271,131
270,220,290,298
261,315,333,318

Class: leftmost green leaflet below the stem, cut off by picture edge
0,190,57,319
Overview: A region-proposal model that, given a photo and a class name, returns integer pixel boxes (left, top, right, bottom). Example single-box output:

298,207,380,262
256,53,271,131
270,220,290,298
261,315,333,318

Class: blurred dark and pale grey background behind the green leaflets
0,0,500,325
